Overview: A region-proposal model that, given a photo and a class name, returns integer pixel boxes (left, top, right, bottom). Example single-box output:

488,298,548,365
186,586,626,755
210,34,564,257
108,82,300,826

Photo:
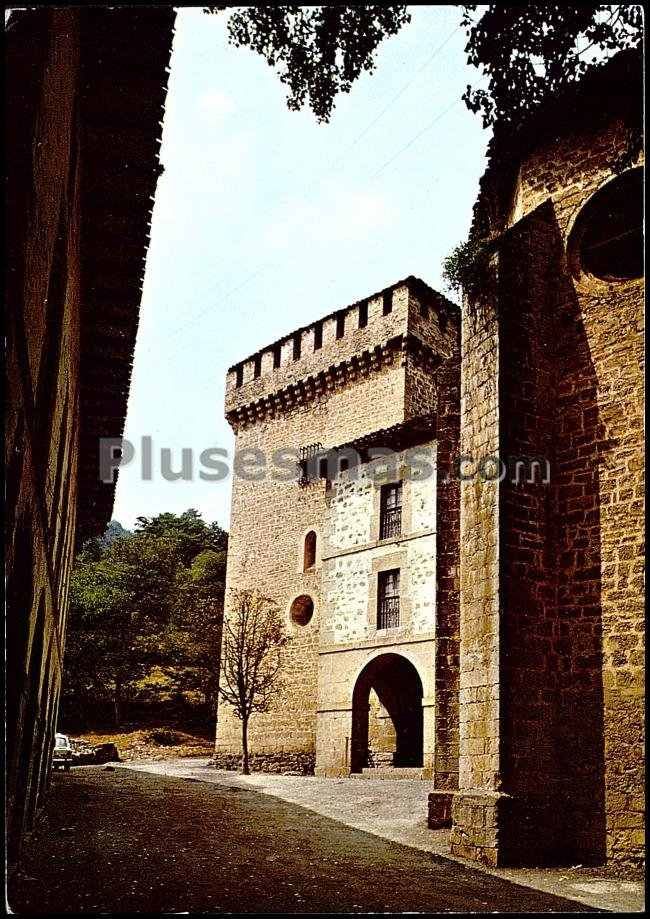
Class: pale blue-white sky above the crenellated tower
113,6,488,529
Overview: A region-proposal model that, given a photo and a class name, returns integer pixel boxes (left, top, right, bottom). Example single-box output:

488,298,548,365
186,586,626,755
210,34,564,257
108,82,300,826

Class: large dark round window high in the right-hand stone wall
569,167,643,281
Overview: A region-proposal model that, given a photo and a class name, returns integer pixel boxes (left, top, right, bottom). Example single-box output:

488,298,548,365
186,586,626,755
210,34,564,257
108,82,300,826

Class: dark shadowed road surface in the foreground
9,767,589,913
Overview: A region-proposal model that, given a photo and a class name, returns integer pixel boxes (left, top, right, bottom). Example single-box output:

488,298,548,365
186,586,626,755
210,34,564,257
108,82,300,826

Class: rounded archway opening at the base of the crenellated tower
350,654,424,772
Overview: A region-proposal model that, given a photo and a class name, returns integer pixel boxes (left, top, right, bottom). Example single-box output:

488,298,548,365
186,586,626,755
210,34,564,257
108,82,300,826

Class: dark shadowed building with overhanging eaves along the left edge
5,7,174,861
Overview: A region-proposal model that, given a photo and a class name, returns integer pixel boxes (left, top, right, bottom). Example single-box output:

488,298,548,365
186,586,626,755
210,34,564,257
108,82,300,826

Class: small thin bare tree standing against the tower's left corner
219,590,289,775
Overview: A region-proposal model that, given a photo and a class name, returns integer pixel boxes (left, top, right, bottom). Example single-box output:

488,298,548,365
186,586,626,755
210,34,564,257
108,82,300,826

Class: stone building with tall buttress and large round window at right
440,52,644,865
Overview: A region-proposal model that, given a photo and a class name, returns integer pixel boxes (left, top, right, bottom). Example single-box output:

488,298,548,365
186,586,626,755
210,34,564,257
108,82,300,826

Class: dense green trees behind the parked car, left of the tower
63,510,228,724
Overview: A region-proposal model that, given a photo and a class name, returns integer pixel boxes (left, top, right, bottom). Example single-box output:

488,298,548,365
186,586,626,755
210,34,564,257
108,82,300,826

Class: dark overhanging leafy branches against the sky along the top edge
208,3,643,127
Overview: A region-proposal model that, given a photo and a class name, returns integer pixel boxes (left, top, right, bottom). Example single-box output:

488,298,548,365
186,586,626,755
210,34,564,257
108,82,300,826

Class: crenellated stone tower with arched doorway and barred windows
215,277,460,787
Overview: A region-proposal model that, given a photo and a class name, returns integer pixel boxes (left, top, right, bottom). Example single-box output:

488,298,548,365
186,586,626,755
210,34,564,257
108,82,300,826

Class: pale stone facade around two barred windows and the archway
316,442,437,776
